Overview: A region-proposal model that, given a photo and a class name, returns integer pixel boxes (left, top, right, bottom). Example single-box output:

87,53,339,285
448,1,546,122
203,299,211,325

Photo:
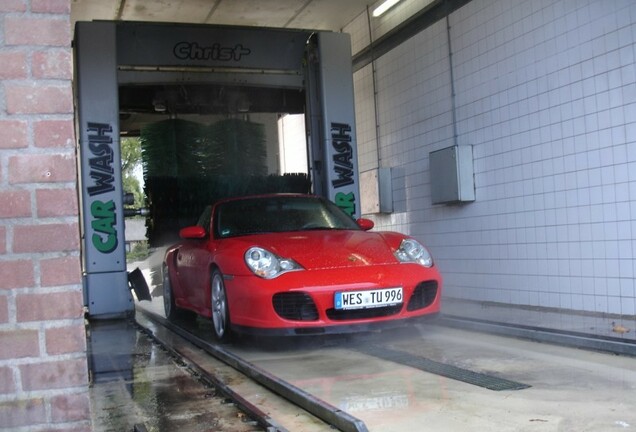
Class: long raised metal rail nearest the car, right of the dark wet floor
137,308,368,432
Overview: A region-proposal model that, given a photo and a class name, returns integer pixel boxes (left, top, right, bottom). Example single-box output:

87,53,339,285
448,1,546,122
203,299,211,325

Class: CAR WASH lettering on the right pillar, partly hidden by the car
331,123,356,216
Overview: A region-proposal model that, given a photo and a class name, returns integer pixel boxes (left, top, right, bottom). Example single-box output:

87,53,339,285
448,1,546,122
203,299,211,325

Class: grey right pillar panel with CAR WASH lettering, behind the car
318,32,360,218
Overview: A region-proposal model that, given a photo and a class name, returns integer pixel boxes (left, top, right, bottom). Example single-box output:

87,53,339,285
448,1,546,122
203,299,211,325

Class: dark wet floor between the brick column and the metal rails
89,320,263,432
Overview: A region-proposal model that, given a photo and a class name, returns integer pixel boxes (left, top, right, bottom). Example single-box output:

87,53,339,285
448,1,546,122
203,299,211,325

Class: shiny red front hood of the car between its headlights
241,230,403,270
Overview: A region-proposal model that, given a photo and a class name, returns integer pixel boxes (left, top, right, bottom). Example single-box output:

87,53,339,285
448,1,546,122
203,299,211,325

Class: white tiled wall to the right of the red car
345,0,636,315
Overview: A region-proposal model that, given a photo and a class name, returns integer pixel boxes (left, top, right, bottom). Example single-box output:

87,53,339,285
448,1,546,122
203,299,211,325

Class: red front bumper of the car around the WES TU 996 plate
225,264,442,334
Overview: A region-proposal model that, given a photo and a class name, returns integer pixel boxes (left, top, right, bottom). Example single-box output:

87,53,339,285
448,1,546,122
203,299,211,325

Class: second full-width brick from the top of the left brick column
5,82,73,114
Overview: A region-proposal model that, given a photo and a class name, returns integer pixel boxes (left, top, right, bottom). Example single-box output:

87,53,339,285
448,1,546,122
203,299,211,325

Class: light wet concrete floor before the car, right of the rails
235,326,636,431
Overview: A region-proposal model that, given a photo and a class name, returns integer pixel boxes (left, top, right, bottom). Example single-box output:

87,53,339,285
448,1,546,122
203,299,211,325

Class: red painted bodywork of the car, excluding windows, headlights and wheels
165,194,442,336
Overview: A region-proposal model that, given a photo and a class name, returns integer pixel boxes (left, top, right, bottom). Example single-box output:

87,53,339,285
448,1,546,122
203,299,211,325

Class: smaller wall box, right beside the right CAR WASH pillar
360,168,393,214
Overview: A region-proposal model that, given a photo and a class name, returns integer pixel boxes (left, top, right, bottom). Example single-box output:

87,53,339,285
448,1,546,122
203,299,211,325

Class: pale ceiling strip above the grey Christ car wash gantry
71,0,376,31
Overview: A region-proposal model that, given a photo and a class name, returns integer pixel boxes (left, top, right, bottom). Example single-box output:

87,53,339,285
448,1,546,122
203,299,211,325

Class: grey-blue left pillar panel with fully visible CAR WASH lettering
75,22,126,274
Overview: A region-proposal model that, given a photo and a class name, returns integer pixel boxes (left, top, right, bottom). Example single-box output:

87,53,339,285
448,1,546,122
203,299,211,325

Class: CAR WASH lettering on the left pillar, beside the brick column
86,122,117,253
